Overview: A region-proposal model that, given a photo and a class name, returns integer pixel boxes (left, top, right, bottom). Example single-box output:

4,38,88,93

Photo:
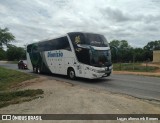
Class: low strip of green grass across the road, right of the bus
113,63,159,72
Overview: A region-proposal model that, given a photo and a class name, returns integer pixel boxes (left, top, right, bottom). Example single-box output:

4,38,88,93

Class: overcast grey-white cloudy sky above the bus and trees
0,0,160,47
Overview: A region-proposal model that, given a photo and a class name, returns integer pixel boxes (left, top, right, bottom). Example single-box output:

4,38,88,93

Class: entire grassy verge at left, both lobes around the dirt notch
0,67,43,108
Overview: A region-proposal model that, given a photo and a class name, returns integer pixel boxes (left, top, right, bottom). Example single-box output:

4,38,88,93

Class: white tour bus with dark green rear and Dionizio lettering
27,32,112,79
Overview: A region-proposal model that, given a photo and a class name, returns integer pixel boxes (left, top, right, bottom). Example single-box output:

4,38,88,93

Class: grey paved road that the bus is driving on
0,63,160,101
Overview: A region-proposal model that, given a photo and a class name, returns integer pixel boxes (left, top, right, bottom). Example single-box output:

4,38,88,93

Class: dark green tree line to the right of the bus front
109,40,160,63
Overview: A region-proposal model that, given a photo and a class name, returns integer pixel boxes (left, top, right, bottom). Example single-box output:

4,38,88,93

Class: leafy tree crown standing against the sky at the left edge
0,28,15,47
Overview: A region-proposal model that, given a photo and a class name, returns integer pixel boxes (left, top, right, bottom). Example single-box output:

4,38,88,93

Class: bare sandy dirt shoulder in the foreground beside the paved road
0,77,160,114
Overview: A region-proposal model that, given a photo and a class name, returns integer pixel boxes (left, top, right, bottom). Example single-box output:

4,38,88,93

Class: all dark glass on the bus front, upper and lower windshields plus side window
68,32,111,67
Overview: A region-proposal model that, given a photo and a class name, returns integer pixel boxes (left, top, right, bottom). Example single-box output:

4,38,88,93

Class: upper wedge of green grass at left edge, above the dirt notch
0,67,35,91
